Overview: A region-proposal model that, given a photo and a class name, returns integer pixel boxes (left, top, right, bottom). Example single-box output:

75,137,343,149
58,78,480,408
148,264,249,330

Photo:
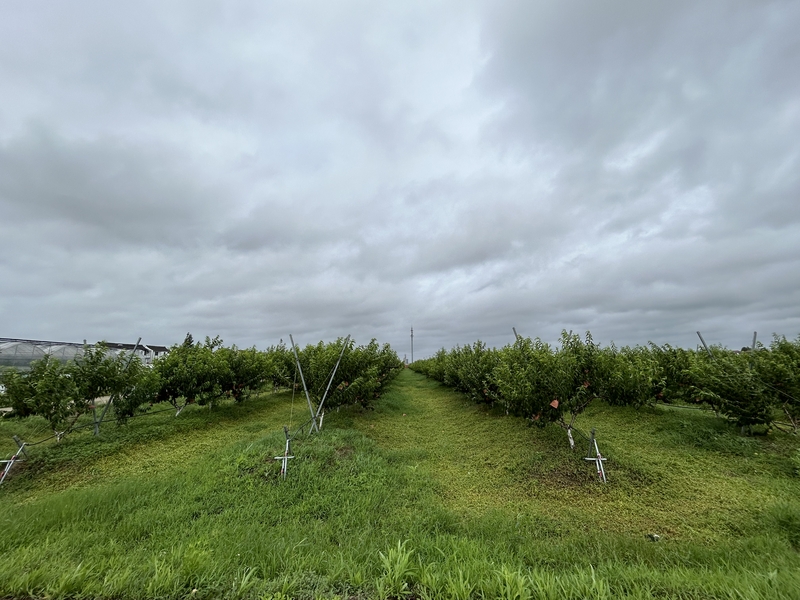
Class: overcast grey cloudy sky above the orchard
0,0,800,358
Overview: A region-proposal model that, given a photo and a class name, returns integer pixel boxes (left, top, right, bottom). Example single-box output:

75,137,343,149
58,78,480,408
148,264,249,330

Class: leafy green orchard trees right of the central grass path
411,331,800,431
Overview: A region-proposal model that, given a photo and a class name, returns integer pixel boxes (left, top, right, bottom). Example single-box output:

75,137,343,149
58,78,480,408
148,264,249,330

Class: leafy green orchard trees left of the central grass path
0,334,401,432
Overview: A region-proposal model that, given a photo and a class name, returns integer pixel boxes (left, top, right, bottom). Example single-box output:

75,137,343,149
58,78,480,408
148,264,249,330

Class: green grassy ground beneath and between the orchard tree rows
0,371,800,598
